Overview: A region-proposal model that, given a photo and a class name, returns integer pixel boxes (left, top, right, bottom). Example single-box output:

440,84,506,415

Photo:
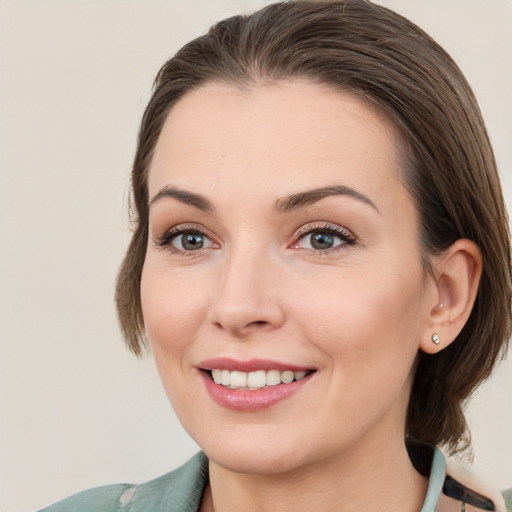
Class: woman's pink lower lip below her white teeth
200,371,313,412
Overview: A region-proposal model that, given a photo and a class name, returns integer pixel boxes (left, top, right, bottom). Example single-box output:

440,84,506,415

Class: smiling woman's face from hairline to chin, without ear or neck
141,82,436,473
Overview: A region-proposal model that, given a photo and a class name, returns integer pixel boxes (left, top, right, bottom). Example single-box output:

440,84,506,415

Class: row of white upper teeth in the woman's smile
212,370,306,389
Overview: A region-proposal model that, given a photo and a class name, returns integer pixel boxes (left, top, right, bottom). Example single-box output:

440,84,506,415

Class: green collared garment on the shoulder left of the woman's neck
39,452,208,512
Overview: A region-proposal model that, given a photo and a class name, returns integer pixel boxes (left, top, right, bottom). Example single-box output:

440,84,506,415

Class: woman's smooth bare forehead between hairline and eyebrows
149,81,403,216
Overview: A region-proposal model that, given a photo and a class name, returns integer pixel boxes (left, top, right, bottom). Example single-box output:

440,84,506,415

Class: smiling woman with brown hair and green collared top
39,0,511,512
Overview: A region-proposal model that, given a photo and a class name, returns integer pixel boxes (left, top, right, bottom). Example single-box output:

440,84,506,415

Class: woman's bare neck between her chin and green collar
202,438,427,512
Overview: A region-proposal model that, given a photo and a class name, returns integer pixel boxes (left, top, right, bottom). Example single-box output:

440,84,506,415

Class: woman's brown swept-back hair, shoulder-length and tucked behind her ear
116,0,511,451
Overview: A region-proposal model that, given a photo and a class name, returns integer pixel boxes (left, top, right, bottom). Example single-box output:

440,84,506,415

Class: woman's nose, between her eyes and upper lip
210,248,285,337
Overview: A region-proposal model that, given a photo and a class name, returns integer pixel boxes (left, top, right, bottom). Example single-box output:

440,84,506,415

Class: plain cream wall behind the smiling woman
0,0,512,512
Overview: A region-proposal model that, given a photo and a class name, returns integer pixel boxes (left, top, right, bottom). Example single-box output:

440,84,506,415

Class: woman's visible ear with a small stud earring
420,239,482,354
